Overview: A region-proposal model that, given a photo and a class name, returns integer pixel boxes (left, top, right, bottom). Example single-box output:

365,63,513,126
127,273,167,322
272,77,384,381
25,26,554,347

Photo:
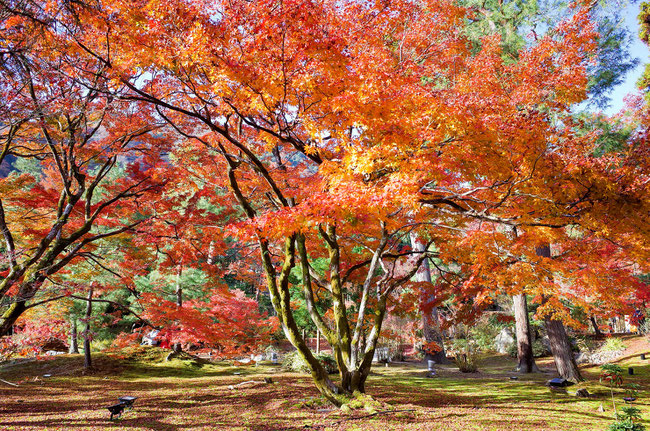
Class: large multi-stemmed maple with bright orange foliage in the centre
1,0,648,405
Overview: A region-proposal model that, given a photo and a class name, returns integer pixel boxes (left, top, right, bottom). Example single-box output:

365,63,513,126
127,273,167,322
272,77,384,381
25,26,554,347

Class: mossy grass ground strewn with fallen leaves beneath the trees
0,340,650,431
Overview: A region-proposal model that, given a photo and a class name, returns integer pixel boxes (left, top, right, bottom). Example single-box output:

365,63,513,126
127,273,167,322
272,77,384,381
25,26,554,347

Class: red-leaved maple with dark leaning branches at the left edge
0,3,165,335
